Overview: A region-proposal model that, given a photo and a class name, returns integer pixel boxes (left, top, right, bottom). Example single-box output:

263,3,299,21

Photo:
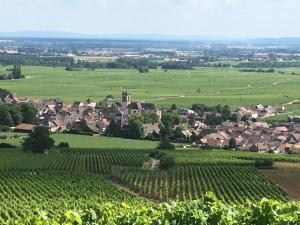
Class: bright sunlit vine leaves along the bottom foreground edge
19,192,300,225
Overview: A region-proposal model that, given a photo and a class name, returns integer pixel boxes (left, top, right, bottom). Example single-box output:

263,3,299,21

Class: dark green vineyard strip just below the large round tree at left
0,150,146,174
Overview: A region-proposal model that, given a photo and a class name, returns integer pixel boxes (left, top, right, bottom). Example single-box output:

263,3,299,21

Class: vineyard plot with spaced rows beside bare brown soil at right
112,165,287,203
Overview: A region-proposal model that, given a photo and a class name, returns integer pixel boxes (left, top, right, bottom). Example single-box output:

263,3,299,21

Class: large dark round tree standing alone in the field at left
22,127,54,153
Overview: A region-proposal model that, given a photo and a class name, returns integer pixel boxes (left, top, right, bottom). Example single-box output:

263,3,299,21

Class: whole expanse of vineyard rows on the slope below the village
0,148,300,225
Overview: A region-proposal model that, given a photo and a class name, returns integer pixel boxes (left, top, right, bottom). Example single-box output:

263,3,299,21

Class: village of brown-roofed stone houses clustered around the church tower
1,91,300,154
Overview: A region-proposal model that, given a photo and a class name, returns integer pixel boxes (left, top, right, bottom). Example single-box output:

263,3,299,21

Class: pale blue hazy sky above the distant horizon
0,0,300,37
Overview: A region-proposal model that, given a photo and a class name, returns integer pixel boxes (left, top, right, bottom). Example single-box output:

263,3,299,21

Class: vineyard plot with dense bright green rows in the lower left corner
0,171,145,224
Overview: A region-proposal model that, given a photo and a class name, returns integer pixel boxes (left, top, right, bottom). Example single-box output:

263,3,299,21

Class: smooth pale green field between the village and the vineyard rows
0,132,158,149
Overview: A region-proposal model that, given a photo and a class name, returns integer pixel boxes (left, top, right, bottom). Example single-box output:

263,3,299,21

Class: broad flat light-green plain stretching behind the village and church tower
0,66,300,110
